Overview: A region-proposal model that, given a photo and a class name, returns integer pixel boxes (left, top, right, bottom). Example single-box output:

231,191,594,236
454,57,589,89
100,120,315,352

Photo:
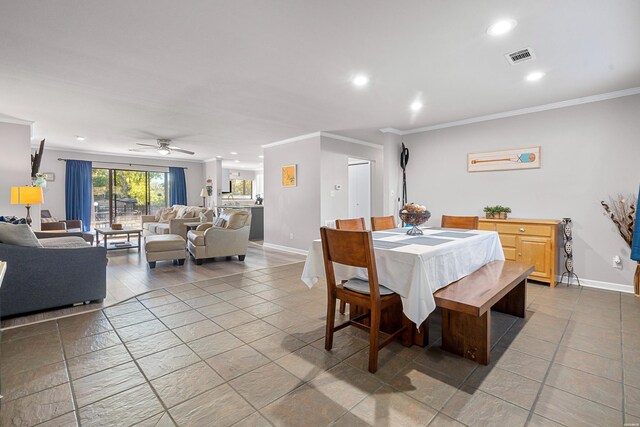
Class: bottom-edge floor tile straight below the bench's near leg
442,386,529,426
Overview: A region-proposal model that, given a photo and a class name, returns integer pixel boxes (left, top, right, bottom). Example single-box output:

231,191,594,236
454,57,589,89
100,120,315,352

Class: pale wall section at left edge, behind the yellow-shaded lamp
0,122,34,221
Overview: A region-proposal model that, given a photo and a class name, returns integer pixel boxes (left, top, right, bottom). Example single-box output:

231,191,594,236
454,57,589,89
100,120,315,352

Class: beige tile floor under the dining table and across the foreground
0,264,640,426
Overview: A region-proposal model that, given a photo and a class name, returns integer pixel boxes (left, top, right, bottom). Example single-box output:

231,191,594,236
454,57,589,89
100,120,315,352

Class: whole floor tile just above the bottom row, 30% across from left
151,362,224,408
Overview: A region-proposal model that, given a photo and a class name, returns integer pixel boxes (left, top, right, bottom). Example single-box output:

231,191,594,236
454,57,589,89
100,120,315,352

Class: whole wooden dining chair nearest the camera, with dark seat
320,227,412,373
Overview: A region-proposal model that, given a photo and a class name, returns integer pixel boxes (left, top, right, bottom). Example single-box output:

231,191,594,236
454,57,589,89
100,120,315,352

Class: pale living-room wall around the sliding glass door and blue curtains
40,147,206,218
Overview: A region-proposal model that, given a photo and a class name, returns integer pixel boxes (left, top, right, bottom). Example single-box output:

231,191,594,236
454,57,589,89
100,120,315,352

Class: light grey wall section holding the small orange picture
264,137,321,251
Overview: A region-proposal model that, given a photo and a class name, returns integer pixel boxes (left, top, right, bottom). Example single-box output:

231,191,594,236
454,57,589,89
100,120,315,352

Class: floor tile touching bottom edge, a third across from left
169,384,254,427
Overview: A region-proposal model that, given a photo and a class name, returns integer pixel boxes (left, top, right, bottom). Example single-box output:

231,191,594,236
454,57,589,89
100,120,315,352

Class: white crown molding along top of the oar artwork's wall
380,87,640,136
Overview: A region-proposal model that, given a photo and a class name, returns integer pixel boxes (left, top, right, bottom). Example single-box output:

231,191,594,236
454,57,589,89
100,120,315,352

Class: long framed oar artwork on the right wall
467,147,540,172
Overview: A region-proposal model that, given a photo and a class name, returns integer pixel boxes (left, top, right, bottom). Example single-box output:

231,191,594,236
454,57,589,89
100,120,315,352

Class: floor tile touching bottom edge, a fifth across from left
80,384,163,427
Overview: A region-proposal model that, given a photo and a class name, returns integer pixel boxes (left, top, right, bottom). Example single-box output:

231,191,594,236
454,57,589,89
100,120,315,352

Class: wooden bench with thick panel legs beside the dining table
433,261,533,365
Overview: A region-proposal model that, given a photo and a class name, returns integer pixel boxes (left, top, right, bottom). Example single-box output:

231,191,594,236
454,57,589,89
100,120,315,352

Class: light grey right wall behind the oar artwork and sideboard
403,95,640,286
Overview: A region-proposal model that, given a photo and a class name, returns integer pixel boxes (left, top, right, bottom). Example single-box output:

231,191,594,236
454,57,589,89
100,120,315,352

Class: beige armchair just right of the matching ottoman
187,209,251,265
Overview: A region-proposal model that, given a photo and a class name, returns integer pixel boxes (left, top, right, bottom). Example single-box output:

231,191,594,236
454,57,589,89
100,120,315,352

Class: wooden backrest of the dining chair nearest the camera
320,227,380,300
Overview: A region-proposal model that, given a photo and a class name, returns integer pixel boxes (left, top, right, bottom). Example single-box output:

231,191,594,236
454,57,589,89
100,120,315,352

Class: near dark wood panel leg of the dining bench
442,308,491,365
